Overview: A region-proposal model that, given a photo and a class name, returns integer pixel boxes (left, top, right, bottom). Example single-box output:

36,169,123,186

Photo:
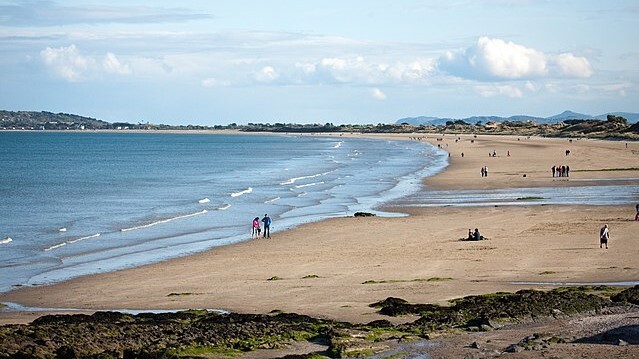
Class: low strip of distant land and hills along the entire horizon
0,110,639,140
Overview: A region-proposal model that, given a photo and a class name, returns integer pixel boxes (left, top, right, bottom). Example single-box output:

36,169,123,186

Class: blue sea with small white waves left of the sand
0,132,446,291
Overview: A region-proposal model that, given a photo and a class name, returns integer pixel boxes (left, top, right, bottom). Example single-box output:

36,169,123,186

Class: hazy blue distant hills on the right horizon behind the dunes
395,110,639,126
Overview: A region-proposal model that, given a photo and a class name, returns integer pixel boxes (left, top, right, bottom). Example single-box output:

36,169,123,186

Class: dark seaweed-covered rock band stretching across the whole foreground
0,287,639,358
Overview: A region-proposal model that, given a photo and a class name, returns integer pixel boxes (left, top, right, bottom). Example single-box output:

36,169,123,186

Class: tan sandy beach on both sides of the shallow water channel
0,134,639,359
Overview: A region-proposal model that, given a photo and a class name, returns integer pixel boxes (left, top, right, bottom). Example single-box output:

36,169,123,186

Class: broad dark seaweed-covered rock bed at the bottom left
0,311,351,358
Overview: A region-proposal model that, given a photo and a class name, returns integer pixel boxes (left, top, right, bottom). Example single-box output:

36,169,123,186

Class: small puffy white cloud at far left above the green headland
40,44,132,82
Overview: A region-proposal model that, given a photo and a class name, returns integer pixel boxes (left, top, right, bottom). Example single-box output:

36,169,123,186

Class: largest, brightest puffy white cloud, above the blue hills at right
438,36,593,80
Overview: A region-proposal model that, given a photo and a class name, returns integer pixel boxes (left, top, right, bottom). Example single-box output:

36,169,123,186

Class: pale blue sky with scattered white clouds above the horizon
0,0,639,125
